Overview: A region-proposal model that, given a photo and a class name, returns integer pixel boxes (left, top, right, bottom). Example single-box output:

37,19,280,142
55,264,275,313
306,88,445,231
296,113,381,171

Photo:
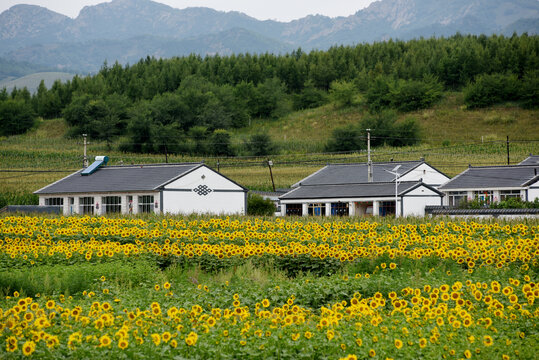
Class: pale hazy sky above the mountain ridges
0,0,375,21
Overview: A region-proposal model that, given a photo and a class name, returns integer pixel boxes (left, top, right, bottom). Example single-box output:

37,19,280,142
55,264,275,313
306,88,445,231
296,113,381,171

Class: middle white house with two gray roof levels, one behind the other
279,160,449,216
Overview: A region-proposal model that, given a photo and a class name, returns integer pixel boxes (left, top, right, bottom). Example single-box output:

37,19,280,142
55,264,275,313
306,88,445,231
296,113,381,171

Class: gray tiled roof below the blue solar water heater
35,163,202,194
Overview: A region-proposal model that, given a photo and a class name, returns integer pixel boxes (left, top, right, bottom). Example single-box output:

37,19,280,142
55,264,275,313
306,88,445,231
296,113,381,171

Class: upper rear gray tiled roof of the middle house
292,161,423,187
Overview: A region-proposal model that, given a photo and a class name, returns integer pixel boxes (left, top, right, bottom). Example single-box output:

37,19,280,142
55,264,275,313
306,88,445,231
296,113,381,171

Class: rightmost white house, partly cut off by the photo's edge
438,155,539,207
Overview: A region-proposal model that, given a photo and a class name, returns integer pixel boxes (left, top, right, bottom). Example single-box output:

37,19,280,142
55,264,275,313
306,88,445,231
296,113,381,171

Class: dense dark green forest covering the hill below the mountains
0,34,539,156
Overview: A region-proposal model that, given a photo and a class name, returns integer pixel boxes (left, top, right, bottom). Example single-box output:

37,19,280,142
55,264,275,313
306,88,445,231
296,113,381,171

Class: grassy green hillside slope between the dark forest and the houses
0,93,539,201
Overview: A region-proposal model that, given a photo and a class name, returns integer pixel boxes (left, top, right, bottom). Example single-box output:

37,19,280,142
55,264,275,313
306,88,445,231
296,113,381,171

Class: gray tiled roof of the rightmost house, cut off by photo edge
438,165,539,190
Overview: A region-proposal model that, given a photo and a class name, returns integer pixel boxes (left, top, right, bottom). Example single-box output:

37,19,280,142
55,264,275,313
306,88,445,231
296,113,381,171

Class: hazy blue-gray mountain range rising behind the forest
0,0,539,73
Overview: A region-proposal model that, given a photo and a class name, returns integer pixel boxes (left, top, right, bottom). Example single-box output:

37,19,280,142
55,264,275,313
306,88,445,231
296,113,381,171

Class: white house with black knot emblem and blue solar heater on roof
34,158,247,215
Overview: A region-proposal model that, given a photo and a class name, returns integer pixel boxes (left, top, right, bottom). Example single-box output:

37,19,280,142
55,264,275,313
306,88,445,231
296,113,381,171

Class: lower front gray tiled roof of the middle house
279,181,437,200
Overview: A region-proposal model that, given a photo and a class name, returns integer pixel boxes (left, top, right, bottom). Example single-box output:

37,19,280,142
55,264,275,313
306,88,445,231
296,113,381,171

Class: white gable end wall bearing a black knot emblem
162,166,247,215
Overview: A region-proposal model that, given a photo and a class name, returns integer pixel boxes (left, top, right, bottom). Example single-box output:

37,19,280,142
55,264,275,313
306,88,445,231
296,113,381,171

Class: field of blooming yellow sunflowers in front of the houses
0,216,539,359
